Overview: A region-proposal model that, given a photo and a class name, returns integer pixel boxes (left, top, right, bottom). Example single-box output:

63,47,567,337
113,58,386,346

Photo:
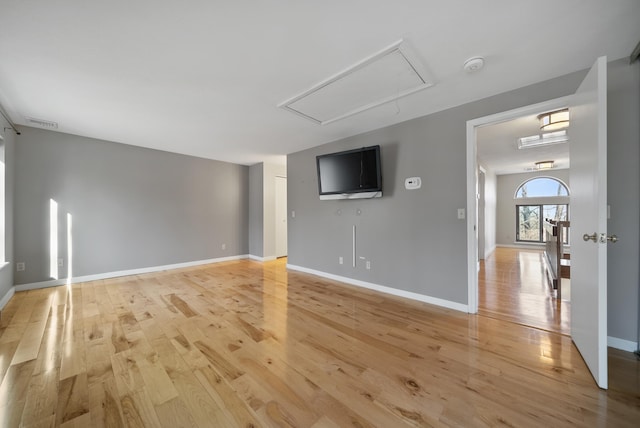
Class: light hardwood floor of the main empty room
0,260,640,428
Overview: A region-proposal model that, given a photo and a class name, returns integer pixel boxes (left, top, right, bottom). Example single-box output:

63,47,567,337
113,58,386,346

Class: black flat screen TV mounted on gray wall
316,146,382,199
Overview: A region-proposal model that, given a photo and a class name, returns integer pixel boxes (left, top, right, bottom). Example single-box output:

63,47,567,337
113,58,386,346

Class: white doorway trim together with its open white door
467,57,615,389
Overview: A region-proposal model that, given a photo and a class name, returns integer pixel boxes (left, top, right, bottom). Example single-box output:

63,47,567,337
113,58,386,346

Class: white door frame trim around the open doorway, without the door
467,95,572,314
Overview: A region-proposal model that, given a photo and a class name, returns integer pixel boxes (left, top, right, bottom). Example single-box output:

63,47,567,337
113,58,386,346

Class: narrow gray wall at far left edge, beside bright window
0,112,16,300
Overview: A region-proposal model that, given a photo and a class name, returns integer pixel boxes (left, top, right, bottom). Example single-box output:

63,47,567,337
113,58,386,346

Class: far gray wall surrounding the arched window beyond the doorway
496,169,571,246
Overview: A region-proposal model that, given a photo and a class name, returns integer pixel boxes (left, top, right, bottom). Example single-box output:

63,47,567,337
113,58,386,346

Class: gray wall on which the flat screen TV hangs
287,68,585,304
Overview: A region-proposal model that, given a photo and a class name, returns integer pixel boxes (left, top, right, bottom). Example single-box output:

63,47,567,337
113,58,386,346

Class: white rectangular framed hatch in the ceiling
278,40,434,125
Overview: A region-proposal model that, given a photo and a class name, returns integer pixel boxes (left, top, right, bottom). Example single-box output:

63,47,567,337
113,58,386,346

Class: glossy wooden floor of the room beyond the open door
478,247,571,335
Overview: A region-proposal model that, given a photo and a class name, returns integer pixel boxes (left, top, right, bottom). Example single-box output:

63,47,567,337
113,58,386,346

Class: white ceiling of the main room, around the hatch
0,0,640,165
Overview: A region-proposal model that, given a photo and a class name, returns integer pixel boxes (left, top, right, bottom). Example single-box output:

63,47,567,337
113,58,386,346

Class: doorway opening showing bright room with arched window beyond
476,107,571,335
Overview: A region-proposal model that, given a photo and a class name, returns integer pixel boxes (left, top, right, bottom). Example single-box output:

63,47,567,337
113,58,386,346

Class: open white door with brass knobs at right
569,57,608,389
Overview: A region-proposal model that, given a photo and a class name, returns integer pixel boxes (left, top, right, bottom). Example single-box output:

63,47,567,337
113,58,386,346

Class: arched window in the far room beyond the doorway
515,177,569,242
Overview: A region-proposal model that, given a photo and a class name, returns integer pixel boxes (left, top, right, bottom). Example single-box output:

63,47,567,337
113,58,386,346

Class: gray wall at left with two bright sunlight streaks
15,128,249,284
